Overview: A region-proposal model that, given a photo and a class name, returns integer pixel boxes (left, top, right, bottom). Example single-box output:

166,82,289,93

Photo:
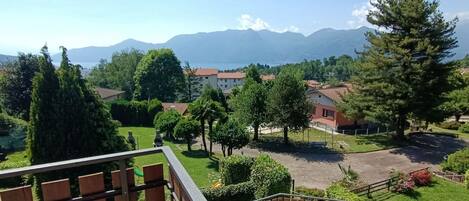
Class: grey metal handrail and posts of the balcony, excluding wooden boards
0,146,206,201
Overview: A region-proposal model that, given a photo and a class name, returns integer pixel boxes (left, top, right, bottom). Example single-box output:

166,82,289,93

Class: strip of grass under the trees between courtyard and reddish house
255,128,402,153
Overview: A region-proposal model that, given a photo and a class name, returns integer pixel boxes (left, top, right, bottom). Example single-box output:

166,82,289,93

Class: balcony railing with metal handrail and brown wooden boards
0,146,206,201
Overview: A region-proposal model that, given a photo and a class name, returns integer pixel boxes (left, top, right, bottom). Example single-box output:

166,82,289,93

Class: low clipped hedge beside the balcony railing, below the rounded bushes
202,181,252,201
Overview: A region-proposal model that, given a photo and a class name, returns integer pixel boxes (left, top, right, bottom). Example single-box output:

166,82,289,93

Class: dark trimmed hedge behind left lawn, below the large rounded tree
108,99,163,126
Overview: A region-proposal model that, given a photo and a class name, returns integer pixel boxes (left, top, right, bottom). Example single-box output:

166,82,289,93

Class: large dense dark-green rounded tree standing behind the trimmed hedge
134,49,184,102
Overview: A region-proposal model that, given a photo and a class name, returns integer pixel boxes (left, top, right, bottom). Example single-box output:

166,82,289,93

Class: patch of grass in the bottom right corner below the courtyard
371,177,469,201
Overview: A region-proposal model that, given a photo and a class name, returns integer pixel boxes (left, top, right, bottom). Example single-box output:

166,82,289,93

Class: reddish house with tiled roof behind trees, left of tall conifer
308,85,356,129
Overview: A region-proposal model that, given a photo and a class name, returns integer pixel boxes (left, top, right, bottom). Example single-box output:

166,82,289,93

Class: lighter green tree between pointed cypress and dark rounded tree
87,49,144,100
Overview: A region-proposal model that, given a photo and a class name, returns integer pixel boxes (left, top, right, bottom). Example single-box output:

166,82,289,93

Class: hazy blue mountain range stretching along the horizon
53,22,469,68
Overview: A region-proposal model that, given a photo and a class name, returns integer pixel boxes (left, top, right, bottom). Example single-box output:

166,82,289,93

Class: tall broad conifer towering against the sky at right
345,0,457,139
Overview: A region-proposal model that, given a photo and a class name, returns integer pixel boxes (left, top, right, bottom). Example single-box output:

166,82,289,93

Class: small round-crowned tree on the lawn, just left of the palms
174,117,200,151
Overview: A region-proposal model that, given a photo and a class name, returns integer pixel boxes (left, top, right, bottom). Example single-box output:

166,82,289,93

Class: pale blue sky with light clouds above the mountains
0,0,469,55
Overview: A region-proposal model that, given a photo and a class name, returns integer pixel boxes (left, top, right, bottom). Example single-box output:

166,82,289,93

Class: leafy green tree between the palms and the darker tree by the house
231,78,267,141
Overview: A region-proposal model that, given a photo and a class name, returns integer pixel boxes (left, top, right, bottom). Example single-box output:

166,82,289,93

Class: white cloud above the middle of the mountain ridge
238,14,300,32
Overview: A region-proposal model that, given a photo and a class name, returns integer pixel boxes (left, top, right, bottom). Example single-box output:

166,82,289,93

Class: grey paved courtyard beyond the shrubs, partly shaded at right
207,135,469,189
